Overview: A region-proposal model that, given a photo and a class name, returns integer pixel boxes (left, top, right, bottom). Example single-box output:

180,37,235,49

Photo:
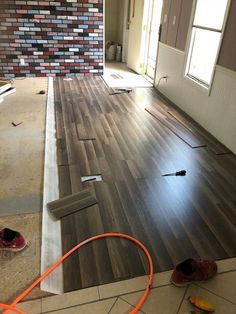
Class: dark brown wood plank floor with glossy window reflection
54,77,236,291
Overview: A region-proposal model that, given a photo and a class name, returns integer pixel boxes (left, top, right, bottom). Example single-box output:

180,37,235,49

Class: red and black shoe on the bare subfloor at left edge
0,228,27,252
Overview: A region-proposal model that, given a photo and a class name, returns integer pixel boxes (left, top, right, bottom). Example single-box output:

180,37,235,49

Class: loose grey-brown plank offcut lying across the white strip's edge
47,190,97,219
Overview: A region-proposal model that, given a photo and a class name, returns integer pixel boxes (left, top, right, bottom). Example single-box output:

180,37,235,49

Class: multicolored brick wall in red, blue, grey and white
0,0,103,77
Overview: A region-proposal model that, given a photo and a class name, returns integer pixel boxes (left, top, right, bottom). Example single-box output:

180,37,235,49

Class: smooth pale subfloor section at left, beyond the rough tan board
0,78,47,216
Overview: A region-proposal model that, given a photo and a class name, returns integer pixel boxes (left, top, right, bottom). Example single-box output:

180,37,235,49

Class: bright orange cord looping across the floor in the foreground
0,232,153,314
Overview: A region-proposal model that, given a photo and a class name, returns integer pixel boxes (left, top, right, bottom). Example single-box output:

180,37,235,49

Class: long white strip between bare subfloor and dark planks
40,77,63,294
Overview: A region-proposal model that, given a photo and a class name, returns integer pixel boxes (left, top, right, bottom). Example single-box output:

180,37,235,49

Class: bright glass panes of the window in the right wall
185,0,229,88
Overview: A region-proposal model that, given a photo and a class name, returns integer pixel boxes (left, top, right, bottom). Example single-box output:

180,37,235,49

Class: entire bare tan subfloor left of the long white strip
0,78,47,302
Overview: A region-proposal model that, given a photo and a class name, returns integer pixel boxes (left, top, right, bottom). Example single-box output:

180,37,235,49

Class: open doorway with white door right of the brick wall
104,0,163,87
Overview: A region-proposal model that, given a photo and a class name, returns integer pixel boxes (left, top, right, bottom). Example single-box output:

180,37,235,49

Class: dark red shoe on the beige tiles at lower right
170,259,217,286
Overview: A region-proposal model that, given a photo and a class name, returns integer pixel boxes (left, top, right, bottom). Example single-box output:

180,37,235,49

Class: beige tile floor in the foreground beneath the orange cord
10,258,236,314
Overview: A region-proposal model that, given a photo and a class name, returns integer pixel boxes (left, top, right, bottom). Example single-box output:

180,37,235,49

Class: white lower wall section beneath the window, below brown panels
156,43,236,154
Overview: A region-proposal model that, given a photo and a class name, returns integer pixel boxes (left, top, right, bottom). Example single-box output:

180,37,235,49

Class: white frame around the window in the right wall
183,0,231,95
